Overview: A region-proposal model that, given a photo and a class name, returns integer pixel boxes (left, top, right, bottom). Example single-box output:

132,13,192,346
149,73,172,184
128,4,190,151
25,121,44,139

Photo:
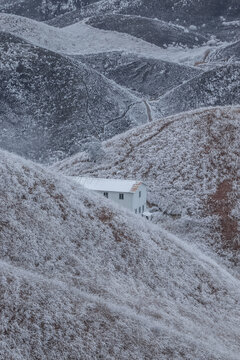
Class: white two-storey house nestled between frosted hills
75,177,147,215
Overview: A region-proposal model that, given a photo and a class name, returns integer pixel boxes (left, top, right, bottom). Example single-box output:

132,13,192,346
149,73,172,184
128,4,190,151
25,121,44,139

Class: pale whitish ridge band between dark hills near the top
0,14,214,65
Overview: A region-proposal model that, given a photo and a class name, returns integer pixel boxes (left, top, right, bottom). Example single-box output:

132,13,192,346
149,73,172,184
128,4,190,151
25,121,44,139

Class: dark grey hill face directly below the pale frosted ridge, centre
74,51,201,99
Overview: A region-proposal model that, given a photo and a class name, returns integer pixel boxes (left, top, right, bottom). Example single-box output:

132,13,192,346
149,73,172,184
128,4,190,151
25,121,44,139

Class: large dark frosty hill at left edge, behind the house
0,33,147,162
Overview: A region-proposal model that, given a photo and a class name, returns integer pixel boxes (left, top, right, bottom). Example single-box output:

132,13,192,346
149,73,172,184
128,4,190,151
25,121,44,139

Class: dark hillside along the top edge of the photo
47,0,240,32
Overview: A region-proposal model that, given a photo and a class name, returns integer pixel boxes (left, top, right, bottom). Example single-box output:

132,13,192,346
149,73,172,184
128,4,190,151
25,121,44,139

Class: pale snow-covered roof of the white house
74,176,144,193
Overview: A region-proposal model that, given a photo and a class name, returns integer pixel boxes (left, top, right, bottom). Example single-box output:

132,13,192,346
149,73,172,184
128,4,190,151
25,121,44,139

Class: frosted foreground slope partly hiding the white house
0,152,240,360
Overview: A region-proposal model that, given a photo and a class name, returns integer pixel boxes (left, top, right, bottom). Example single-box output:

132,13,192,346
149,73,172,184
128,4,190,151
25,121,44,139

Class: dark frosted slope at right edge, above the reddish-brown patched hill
152,63,240,116
